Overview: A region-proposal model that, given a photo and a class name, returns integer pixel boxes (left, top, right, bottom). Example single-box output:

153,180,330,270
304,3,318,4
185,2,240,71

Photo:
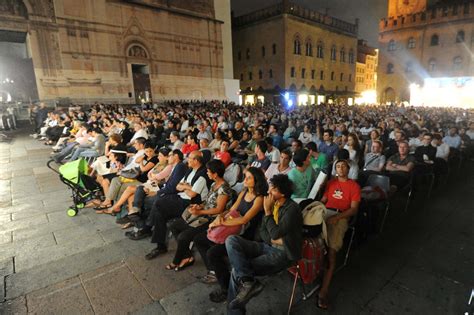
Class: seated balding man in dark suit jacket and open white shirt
145,151,208,259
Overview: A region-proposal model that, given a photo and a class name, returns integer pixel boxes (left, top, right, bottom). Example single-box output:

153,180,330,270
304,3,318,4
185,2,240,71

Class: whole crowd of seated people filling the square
31,101,474,313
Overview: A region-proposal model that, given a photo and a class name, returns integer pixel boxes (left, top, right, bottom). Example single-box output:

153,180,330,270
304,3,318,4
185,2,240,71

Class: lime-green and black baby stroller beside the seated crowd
46,159,101,217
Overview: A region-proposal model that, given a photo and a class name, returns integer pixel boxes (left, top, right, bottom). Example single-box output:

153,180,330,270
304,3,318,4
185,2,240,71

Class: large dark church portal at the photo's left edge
0,30,38,103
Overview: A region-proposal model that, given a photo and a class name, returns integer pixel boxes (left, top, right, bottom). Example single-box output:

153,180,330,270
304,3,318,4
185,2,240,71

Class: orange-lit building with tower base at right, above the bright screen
378,0,474,103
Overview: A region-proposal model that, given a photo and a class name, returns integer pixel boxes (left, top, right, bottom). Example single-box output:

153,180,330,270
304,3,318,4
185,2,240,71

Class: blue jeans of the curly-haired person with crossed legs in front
225,235,291,314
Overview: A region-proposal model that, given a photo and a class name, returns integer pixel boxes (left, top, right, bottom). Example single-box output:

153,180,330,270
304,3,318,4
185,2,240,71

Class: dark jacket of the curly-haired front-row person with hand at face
260,199,303,261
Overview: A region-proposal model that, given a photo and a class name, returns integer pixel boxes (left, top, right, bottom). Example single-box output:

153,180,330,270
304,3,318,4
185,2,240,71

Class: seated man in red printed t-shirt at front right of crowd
318,160,360,309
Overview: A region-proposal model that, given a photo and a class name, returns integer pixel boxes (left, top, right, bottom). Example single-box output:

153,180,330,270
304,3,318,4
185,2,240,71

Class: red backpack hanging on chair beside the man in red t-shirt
288,237,326,284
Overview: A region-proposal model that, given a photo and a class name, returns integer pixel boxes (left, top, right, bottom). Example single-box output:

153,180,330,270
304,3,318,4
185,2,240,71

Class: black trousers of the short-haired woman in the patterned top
169,218,209,265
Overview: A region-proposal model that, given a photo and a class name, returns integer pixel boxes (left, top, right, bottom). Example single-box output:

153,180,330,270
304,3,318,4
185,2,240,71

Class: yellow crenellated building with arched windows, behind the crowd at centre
232,1,357,105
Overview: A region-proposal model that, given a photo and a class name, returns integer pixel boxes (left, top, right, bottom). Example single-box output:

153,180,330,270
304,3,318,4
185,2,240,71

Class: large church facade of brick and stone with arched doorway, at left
0,0,238,103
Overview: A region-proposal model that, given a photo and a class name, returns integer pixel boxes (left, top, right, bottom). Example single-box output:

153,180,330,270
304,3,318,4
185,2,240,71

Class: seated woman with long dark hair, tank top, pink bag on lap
194,167,268,303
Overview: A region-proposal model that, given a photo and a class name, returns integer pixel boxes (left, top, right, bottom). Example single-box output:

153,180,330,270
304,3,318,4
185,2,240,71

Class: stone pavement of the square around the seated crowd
0,133,474,315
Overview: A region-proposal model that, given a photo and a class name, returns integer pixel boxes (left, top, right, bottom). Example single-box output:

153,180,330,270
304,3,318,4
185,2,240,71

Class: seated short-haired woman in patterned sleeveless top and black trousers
166,160,232,271
